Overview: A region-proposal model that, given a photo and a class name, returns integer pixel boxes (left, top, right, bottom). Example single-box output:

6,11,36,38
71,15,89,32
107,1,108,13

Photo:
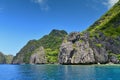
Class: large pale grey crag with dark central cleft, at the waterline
58,33,95,64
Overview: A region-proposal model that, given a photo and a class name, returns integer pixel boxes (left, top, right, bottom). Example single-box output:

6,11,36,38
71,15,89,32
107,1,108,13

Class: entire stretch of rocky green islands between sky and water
0,0,120,64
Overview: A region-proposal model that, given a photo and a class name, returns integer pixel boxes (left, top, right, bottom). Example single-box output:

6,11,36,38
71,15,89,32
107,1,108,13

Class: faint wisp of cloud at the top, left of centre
32,0,49,11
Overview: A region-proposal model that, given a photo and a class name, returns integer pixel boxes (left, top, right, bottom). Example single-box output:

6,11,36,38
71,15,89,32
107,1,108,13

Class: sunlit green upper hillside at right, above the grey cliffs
87,1,120,38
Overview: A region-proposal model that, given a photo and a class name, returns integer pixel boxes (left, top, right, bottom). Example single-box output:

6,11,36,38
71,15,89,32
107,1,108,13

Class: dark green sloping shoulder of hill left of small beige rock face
13,40,39,63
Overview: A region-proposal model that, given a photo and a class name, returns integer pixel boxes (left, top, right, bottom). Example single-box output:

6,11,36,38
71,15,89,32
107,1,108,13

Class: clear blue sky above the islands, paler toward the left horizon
0,0,118,55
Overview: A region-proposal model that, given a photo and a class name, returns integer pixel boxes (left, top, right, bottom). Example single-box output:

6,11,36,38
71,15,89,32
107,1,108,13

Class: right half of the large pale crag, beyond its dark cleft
71,41,95,64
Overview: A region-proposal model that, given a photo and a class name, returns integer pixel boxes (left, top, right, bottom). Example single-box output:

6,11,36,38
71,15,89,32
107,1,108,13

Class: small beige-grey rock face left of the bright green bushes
30,47,46,64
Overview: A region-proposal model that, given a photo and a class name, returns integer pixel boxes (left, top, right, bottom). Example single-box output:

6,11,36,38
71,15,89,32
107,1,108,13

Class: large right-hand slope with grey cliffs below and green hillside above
59,0,120,64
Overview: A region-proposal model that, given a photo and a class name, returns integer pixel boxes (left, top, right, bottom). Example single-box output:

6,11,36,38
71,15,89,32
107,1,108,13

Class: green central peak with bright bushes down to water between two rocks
38,30,67,63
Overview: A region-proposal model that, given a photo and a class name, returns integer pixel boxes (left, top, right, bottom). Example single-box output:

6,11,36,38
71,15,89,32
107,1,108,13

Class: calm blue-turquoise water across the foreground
0,65,120,80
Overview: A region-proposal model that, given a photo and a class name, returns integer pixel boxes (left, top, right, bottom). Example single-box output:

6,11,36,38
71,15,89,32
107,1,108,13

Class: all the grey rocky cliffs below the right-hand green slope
58,32,120,64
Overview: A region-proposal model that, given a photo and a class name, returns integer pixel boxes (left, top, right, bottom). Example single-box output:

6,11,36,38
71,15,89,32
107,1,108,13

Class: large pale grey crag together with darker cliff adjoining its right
59,33,109,64
